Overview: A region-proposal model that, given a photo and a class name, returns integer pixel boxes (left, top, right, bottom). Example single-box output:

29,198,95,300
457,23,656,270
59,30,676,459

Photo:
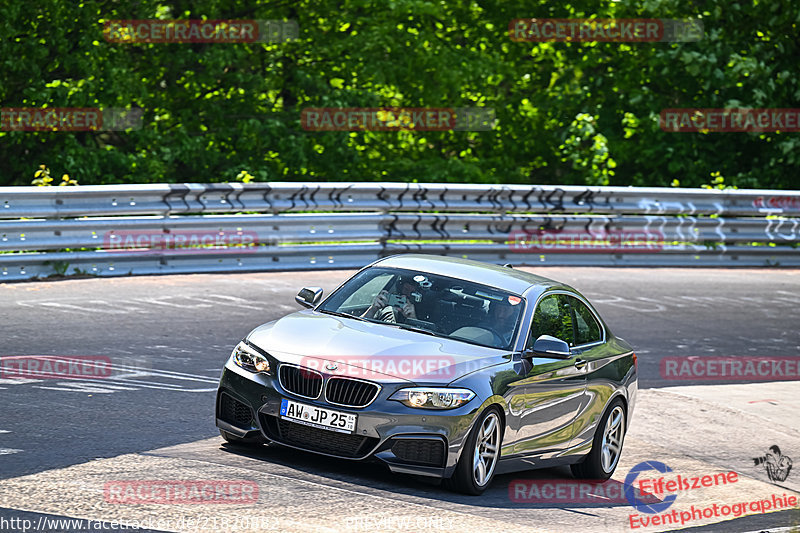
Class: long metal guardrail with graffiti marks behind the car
0,183,800,281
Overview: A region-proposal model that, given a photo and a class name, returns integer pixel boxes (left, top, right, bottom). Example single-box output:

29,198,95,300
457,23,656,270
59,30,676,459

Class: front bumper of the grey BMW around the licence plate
216,360,481,478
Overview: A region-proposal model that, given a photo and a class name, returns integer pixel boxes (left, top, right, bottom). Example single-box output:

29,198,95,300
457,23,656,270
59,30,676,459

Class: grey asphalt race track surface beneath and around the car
0,267,800,533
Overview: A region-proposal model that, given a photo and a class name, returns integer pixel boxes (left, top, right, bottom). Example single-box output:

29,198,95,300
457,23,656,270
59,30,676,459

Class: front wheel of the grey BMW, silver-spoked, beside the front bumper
444,408,503,495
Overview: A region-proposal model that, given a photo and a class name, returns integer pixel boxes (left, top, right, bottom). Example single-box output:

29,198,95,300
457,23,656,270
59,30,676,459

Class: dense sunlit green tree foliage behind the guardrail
0,0,800,188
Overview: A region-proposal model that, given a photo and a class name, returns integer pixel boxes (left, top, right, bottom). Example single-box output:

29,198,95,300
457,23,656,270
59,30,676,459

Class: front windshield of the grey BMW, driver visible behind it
317,267,524,350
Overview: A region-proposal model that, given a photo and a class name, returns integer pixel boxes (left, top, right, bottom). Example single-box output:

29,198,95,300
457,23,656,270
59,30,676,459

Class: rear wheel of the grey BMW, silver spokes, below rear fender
570,398,625,481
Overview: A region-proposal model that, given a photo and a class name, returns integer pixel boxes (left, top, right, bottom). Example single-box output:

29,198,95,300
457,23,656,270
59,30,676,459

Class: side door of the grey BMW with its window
504,293,586,456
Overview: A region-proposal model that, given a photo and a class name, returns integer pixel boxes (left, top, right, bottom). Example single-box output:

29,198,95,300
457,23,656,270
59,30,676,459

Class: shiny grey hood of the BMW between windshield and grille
247,310,511,384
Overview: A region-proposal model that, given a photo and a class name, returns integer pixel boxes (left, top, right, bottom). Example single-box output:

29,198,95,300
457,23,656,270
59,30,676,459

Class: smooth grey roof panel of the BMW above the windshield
373,254,566,294
